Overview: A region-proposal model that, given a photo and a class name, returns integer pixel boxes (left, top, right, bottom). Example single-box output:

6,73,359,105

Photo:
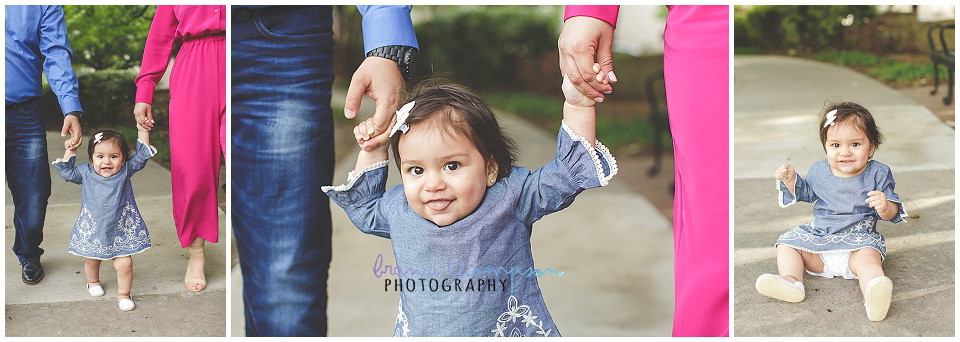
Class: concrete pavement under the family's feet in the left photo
4,132,226,336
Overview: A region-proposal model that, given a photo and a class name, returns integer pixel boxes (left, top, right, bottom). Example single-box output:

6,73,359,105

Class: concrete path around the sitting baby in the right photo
733,56,955,336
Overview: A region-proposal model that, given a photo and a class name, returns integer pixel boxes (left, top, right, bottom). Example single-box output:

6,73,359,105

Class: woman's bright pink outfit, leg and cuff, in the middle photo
564,6,729,336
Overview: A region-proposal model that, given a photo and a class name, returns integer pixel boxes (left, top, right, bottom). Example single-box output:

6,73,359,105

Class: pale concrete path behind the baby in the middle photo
231,92,673,336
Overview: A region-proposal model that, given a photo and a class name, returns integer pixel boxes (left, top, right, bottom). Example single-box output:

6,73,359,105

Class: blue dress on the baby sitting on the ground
774,159,907,259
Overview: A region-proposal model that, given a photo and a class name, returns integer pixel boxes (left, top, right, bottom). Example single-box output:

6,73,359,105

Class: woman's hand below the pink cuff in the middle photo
557,17,617,102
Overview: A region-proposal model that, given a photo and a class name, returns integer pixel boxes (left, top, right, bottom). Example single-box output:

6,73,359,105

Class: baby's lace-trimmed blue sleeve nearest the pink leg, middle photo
511,123,617,225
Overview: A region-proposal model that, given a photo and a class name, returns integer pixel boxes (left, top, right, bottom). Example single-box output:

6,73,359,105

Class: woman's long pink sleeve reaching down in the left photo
134,6,177,103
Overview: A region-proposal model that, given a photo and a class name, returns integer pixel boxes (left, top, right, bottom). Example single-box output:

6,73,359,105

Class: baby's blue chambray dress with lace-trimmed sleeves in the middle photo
323,124,617,336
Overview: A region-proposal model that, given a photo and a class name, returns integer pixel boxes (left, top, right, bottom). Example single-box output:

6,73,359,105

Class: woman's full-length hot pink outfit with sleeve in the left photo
135,6,227,247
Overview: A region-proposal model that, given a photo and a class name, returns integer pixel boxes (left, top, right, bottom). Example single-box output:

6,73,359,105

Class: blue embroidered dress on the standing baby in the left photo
53,140,157,260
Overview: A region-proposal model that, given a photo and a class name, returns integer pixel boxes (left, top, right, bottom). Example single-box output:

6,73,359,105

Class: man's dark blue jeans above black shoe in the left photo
4,97,50,262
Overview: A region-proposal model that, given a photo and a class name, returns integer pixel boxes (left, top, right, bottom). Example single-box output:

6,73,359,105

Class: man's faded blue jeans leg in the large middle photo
231,6,334,336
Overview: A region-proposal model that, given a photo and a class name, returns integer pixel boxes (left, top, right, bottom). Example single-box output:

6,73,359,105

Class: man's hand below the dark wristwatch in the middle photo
343,57,406,151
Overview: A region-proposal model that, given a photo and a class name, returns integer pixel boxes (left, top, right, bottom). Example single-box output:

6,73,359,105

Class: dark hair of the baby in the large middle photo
390,78,517,179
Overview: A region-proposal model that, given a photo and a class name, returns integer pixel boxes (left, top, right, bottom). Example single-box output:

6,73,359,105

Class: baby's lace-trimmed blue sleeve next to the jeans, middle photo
321,160,390,239
